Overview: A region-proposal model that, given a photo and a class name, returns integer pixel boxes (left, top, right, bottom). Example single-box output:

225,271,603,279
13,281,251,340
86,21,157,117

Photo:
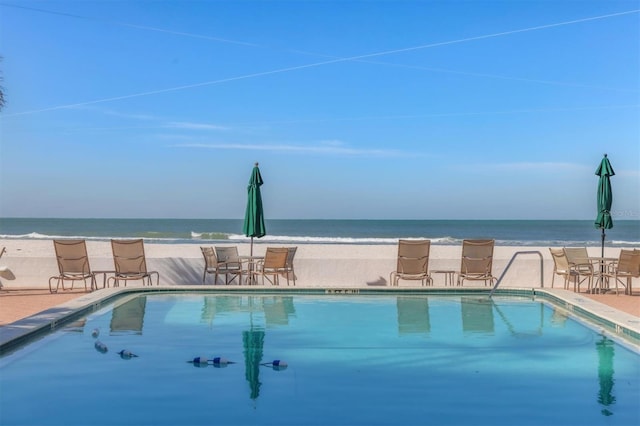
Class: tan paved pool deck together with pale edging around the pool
0,285,640,353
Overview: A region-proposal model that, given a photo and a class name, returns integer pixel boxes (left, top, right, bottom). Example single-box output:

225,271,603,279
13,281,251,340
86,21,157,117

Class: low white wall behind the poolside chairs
0,239,619,289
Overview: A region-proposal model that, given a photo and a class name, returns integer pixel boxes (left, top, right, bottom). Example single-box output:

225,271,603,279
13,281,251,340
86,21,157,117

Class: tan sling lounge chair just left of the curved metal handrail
458,240,498,286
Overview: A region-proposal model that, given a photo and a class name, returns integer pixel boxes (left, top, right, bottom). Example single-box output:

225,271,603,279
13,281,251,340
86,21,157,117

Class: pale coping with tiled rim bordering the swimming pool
0,285,640,356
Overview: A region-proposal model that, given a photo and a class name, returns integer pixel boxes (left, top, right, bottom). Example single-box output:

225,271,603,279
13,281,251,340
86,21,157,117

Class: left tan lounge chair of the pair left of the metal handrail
389,240,433,286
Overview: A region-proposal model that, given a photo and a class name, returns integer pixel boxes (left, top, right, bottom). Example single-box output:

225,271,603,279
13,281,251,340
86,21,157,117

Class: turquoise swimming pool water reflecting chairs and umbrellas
0,293,640,425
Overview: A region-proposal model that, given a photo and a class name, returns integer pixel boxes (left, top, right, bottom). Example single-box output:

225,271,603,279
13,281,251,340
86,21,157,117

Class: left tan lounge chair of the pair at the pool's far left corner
49,240,97,293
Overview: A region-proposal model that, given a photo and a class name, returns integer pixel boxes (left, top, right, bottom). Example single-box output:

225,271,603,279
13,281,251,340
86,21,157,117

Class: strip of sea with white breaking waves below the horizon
0,218,640,247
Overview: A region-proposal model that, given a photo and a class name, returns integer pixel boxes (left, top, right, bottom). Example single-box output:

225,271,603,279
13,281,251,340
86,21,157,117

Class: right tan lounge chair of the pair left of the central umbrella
107,239,160,287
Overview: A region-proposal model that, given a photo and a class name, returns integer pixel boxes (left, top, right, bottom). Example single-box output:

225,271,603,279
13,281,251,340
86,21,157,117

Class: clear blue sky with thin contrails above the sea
0,0,640,220
